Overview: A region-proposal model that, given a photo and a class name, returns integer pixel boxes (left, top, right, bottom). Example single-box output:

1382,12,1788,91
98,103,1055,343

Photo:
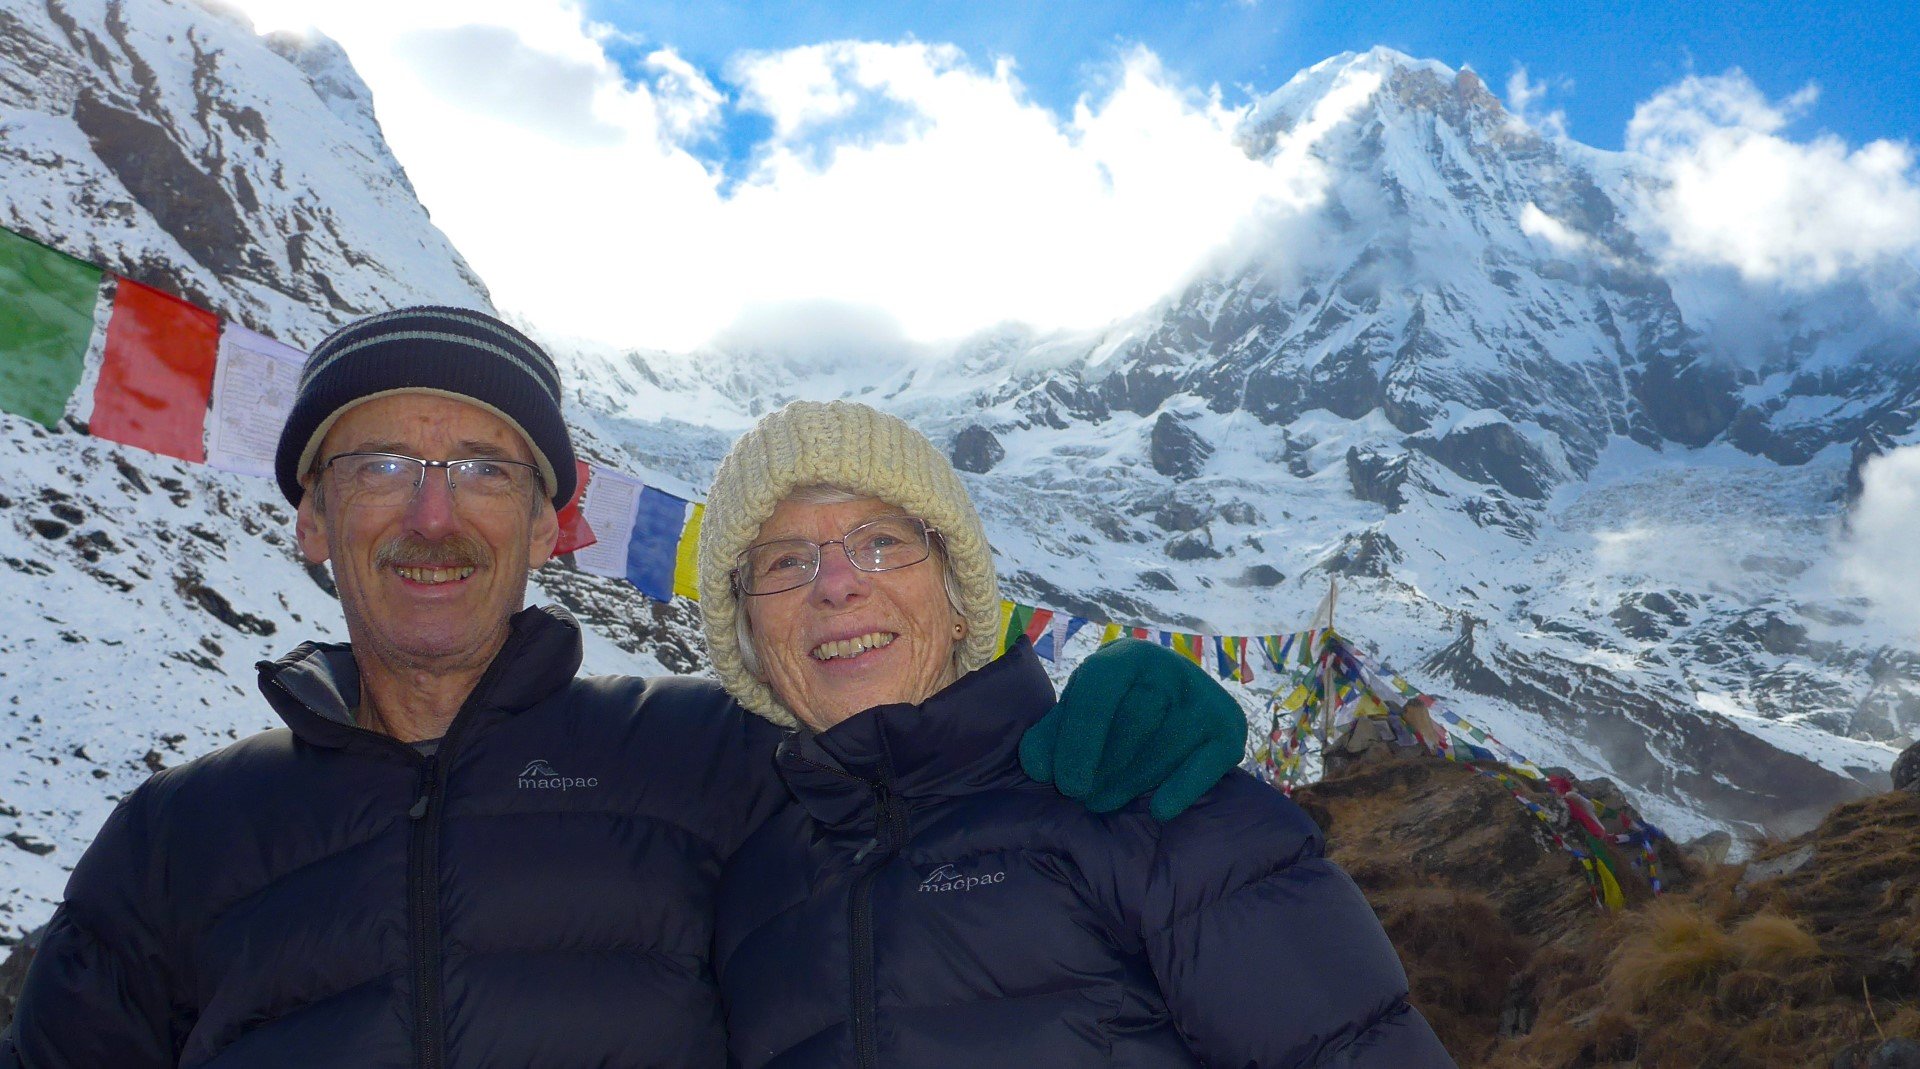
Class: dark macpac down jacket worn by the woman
714,643,1452,1069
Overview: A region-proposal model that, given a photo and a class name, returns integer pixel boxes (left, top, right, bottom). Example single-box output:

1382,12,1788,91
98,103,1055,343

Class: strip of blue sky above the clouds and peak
588,0,1920,166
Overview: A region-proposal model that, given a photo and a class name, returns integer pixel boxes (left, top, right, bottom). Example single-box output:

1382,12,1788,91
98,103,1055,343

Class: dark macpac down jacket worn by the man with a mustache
0,608,783,1069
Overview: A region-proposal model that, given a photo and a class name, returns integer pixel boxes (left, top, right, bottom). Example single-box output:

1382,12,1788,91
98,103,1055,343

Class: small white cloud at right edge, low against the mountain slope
1839,445,1920,645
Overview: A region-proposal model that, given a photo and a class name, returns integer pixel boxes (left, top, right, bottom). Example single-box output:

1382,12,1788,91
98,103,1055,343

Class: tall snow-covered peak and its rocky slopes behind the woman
578,50,1920,833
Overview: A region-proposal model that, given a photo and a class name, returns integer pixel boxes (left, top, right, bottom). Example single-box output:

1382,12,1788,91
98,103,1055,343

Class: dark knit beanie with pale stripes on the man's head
273,305,576,509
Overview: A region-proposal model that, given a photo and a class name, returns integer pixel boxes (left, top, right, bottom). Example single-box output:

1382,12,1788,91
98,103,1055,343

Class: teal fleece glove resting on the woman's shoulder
1020,639,1246,820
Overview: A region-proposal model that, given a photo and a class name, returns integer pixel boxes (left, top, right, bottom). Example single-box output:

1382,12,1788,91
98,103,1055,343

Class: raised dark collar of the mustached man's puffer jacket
255,606,582,752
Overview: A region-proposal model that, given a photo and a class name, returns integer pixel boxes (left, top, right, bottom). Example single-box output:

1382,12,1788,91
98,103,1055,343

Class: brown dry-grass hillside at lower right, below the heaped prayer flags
1302,748,1920,1069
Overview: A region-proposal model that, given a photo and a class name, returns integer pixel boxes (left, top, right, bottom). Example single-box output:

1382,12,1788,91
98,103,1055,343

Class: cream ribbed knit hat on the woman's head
701,401,1000,727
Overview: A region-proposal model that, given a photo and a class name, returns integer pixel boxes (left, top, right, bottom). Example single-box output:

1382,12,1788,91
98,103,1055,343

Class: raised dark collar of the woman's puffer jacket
778,639,1054,829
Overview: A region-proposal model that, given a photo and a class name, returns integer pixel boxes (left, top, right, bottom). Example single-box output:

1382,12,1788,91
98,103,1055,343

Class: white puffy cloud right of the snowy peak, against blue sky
1626,71,1920,290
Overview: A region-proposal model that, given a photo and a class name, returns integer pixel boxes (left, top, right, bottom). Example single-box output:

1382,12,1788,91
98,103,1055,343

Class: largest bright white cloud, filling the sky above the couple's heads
220,0,1325,349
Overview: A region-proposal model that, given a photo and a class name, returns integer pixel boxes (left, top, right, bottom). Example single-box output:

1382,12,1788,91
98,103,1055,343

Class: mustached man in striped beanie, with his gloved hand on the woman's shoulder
0,307,1244,1069
